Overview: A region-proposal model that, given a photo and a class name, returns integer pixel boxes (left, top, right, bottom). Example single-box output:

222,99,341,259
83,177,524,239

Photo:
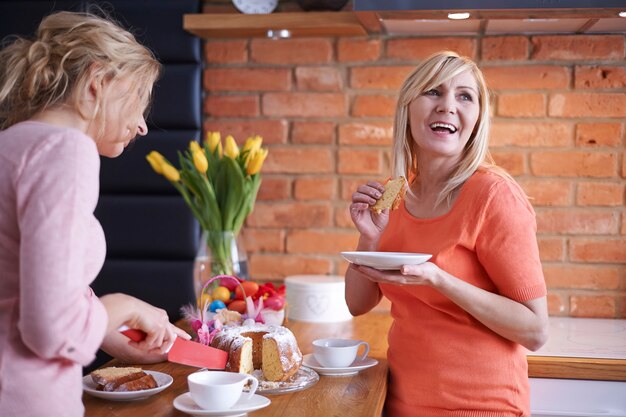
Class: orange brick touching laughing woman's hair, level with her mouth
489,122,573,147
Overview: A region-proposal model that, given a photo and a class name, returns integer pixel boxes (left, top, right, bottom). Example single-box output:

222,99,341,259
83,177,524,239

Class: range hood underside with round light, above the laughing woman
353,0,626,36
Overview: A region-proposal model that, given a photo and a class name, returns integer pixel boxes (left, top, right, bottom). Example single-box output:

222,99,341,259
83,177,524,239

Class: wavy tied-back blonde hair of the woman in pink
0,12,161,130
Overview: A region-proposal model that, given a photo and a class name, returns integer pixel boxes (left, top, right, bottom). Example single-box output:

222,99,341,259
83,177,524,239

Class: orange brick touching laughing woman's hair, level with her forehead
482,65,570,90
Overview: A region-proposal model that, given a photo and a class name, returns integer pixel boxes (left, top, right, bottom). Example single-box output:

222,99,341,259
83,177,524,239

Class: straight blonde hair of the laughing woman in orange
392,51,503,205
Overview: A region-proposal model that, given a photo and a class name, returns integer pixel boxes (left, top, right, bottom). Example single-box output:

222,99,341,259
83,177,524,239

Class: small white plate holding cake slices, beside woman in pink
83,367,174,401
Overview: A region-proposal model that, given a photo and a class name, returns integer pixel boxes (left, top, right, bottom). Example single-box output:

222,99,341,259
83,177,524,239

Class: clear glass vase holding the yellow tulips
194,231,249,306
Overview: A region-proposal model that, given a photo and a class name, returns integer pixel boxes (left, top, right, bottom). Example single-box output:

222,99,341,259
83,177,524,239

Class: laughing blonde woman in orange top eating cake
346,52,548,417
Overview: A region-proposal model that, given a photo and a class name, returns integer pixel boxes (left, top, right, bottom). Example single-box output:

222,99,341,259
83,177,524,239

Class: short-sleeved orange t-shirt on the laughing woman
379,170,546,417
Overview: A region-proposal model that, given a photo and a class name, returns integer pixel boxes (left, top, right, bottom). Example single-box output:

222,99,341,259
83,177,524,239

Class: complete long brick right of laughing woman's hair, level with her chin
530,151,617,178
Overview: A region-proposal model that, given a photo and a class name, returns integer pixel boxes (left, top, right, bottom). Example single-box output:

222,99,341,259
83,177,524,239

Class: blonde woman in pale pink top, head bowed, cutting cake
0,12,189,417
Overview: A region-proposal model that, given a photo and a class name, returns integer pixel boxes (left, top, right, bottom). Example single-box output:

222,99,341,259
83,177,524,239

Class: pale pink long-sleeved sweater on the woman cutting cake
0,122,107,417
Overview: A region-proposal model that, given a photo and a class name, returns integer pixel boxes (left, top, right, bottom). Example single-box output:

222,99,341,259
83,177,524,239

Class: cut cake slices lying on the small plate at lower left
90,366,158,392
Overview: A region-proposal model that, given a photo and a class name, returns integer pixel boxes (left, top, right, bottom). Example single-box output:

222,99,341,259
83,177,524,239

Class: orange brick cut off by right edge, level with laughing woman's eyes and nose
548,93,626,118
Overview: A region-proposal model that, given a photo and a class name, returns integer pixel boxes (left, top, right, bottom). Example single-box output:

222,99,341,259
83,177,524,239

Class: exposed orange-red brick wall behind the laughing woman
204,27,626,317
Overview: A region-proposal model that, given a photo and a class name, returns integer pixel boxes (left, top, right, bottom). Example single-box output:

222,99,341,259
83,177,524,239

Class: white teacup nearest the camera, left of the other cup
187,371,259,411
